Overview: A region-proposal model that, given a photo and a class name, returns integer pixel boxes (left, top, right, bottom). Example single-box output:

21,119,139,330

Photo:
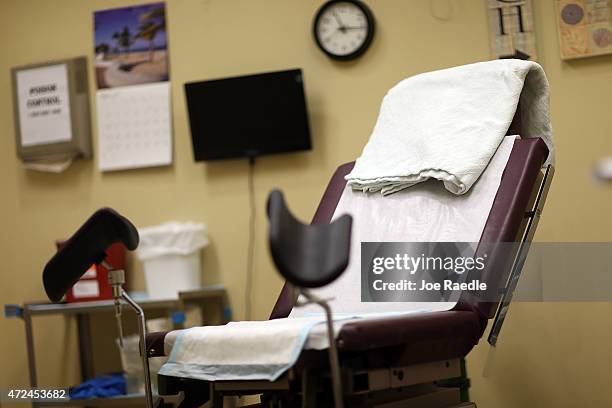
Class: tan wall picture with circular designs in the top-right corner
555,0,612,59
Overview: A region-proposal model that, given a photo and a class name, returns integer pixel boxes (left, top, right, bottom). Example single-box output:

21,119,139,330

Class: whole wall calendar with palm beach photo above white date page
94,3,172,171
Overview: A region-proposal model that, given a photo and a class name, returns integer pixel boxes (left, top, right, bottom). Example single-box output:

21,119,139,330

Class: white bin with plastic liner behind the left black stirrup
137,222,208,299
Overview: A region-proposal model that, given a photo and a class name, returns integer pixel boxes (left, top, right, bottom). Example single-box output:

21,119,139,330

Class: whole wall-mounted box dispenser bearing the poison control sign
11,57,91,171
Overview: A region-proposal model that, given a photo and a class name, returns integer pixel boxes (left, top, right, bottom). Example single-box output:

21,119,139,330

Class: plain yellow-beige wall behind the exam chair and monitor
0,0,612,407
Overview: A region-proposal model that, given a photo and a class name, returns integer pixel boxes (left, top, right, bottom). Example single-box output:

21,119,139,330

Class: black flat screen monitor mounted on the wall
185,69,311,161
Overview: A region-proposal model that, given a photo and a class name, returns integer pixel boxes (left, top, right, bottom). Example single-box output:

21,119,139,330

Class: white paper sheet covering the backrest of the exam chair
290,136,516,317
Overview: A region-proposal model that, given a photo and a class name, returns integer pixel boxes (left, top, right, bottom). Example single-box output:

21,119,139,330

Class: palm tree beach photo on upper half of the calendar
94,3,169,89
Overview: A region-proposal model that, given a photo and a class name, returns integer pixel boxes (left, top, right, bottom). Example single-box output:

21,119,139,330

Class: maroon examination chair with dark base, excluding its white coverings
146,115,553,408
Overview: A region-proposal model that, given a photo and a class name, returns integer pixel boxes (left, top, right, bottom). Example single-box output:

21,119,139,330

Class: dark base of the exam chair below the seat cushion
160,359,475,408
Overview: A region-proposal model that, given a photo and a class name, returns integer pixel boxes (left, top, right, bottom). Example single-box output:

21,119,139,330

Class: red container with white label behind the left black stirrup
56,241,127,303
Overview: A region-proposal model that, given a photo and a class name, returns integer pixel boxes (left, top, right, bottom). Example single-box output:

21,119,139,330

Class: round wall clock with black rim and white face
314,0,374,60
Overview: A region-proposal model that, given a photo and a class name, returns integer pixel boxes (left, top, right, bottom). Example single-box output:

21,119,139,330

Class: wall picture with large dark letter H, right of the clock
487,0,538,60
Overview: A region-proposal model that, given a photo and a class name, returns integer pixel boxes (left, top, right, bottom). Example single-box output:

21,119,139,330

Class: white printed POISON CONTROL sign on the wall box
17,64,72,146
